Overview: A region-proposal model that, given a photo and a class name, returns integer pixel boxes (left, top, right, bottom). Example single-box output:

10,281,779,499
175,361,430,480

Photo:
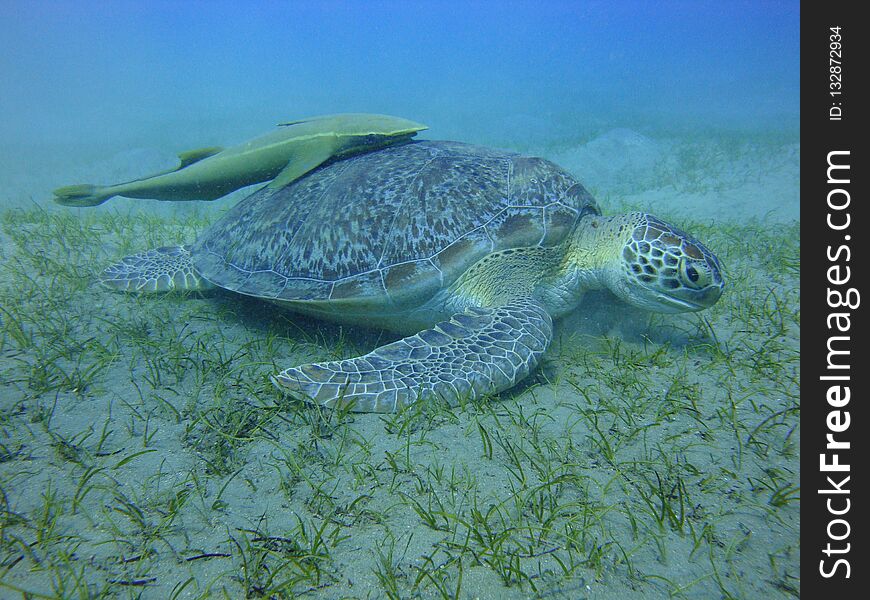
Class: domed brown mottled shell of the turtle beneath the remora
192,141,598,307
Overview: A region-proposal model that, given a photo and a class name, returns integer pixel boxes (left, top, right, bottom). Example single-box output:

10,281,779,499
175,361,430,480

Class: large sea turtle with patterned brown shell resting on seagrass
102,141,724,412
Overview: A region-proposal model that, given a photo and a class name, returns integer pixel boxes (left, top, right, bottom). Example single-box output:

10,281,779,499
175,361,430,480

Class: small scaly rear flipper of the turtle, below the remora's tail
100,246,215,294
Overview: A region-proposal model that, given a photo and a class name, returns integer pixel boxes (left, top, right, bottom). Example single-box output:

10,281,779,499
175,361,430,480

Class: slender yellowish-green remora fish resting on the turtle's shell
54,113,428,206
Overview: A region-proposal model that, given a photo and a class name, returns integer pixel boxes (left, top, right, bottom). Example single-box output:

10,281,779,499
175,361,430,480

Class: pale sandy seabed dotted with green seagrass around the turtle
0,129,800,599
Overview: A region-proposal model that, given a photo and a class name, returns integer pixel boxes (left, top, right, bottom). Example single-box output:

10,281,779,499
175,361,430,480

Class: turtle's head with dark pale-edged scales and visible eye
599,213,725,313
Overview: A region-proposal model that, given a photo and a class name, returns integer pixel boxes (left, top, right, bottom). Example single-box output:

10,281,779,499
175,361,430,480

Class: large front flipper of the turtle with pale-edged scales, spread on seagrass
272,298,553,412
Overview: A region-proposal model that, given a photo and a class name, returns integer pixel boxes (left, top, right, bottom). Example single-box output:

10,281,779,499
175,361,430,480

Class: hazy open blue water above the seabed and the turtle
0,0,799,155
